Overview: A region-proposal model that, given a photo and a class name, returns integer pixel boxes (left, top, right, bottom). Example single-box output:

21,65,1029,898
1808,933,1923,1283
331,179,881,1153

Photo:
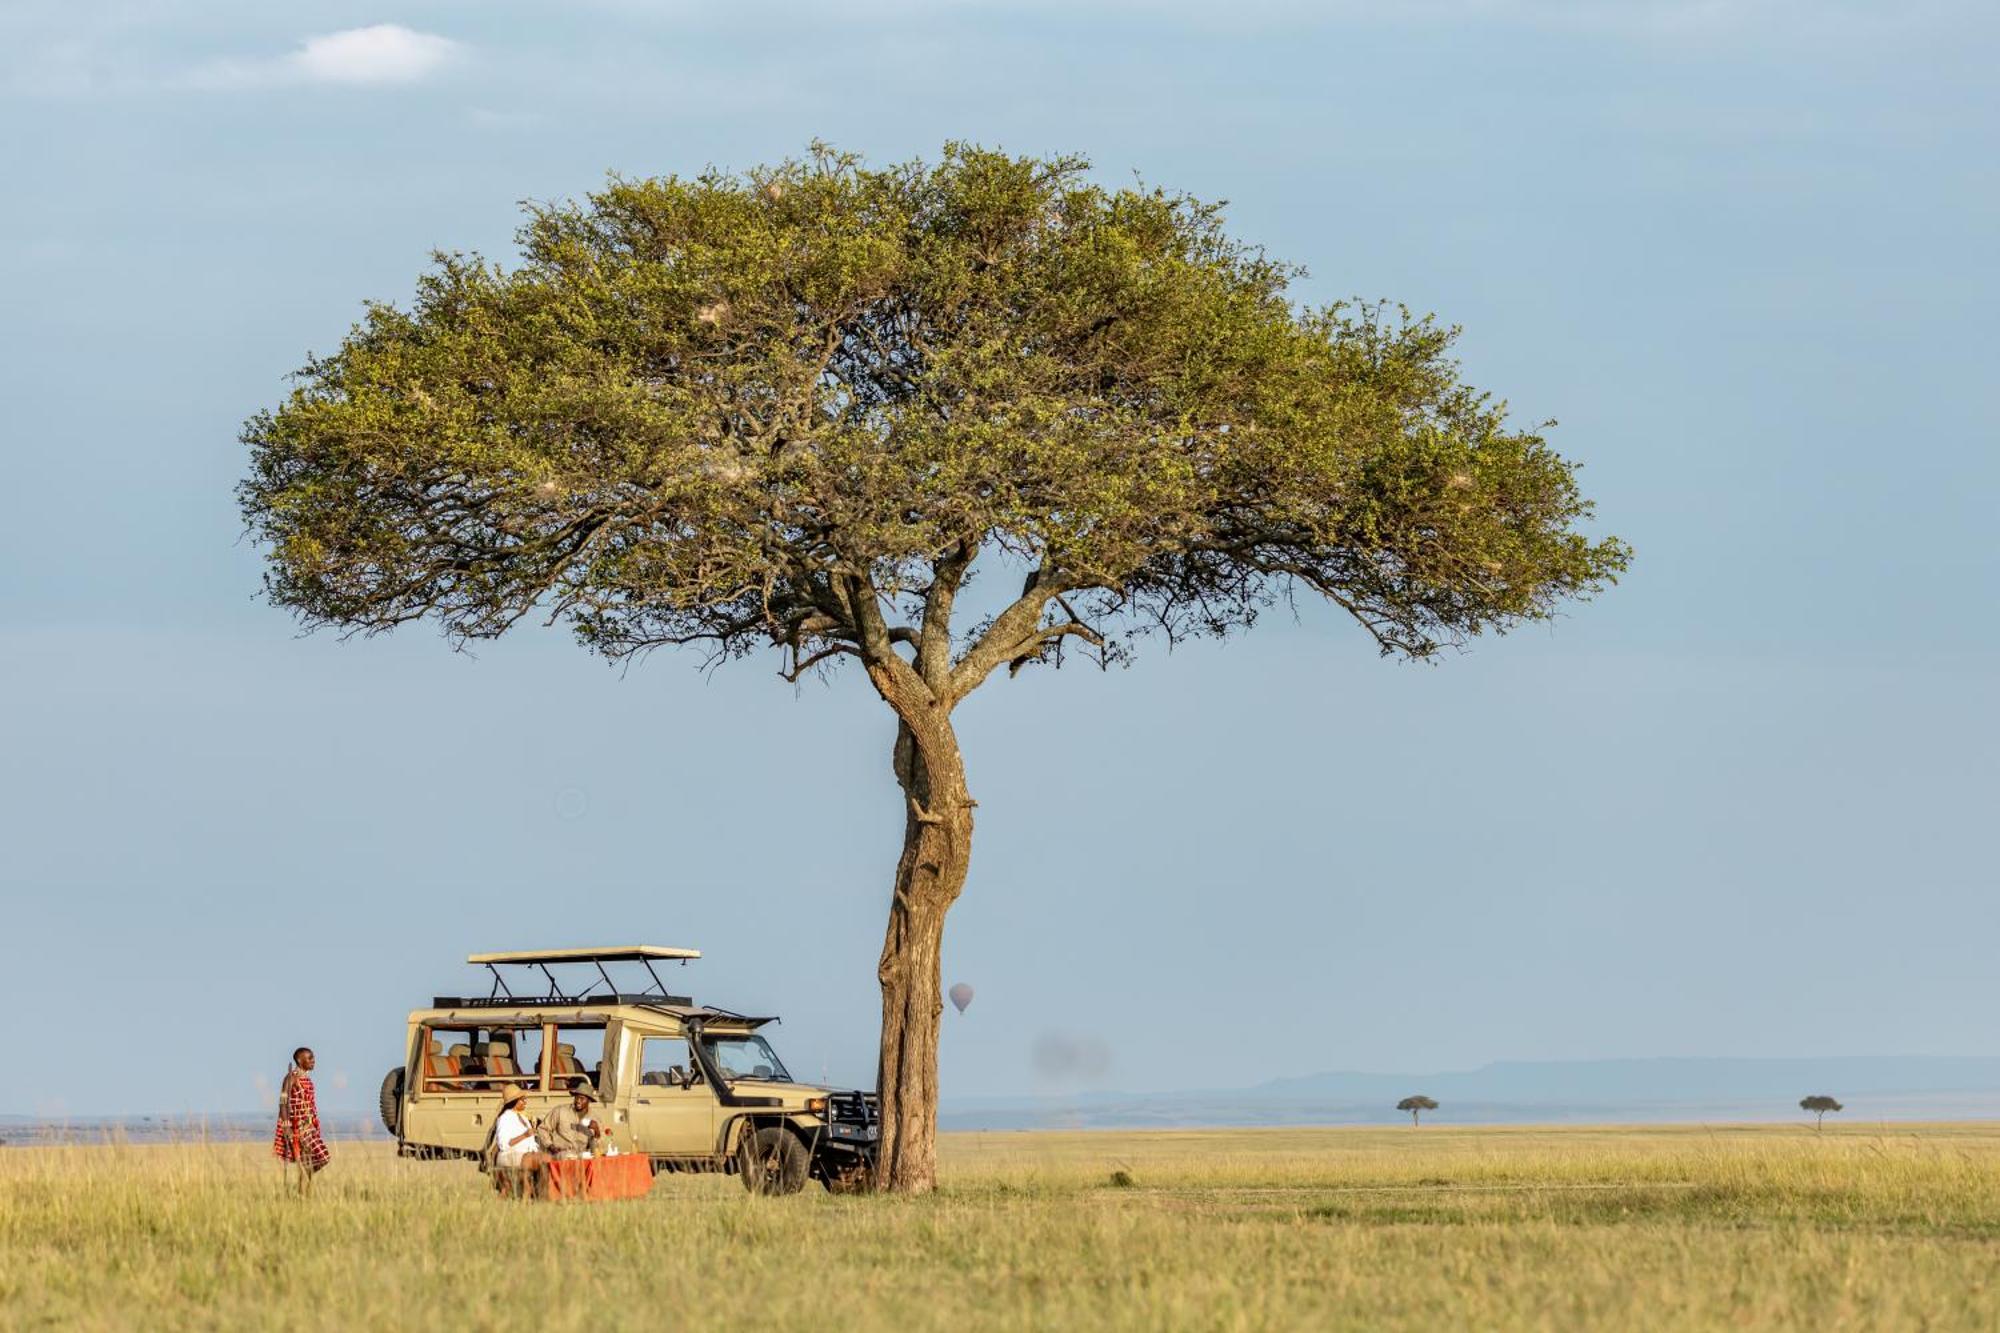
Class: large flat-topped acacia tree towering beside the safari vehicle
240,144,1626,1191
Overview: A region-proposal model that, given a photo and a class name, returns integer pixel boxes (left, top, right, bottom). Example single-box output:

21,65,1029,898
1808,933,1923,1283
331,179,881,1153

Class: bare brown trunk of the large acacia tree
876,717,972,1195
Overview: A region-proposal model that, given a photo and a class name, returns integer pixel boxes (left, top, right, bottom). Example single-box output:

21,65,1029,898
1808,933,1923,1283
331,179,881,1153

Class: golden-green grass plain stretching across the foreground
0,1125,2000,1333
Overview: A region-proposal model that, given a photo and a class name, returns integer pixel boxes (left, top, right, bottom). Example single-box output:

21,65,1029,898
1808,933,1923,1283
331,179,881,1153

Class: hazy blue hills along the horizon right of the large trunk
940,1055,2000,1129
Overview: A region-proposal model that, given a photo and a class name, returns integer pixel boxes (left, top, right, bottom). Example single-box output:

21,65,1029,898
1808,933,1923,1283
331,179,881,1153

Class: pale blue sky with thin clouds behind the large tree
0,0,2000,1113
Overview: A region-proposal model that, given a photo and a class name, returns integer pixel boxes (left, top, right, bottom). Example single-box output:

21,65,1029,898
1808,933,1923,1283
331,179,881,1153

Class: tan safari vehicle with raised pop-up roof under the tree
382,945,878,1195
